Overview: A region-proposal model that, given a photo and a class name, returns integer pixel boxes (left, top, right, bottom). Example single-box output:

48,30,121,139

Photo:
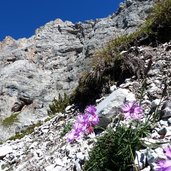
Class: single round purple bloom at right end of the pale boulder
122,102,143,120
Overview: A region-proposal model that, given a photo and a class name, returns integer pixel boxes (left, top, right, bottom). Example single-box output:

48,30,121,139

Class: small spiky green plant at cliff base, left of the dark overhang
48,93,69,115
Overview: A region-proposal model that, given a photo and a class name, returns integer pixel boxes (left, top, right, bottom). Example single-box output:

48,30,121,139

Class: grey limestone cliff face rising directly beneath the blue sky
0,0,153,140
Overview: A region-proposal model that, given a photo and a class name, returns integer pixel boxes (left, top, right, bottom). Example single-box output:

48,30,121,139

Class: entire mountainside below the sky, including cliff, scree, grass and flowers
0,0,171,171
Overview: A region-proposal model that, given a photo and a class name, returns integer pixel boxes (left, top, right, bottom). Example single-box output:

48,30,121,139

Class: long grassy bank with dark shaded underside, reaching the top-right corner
70,0,171,109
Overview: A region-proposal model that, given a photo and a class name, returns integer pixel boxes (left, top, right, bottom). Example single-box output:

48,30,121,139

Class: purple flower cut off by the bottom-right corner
156,146,171,171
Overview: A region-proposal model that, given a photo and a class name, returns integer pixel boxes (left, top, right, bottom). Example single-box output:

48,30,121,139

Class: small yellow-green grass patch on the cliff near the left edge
2,112,20,127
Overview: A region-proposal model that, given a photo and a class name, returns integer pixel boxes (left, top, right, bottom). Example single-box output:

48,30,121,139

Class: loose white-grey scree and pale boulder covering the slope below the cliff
0,42,171,171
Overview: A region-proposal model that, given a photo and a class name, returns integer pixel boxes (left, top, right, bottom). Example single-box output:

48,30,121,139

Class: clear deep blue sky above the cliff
0,0,123,41
